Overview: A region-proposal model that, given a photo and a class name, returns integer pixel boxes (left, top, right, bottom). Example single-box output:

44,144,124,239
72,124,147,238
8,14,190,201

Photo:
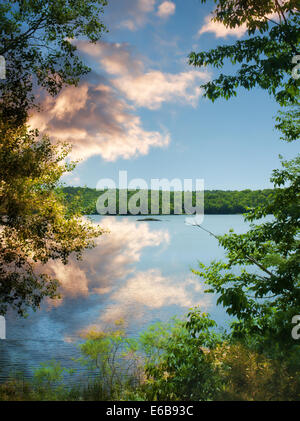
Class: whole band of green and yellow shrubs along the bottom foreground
0,314,300,401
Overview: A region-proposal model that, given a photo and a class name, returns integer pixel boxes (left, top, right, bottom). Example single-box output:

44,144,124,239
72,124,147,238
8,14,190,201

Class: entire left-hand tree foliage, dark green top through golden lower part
0,0,107,315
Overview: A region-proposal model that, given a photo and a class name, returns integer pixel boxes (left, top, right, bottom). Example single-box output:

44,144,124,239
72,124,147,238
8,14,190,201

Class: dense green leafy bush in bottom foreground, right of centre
140,308,221,401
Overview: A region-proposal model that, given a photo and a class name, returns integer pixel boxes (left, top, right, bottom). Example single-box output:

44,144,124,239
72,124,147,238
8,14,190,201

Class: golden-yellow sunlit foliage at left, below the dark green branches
0,120,103,315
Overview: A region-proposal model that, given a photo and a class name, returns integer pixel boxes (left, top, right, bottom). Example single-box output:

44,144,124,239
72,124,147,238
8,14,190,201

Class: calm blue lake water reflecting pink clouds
0,215,262,379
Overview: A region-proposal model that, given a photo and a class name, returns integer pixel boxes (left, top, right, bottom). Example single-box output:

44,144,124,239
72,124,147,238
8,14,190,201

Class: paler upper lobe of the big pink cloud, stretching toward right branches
76,42,210,110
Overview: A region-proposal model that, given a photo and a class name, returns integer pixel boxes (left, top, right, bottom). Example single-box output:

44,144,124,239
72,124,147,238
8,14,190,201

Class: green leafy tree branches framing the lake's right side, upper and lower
190,0,300,363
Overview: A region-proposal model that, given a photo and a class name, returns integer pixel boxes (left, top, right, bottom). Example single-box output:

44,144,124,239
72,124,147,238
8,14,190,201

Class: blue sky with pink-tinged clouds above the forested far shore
31,0,297,190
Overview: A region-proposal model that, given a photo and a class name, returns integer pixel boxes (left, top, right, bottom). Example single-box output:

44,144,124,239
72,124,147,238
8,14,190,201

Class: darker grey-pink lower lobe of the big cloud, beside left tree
29,82,170,161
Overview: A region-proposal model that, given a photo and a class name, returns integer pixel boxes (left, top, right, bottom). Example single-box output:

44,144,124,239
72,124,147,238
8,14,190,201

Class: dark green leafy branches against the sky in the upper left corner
0,0,107,124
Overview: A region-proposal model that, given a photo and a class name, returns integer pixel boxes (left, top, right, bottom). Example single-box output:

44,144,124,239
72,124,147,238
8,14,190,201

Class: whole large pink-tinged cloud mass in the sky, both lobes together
29,41,210,161
